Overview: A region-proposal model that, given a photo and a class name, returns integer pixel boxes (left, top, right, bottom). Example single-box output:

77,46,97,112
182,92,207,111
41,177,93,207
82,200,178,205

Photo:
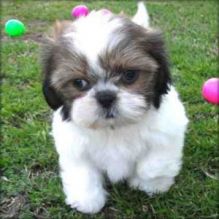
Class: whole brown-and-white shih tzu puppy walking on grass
43,2,188,213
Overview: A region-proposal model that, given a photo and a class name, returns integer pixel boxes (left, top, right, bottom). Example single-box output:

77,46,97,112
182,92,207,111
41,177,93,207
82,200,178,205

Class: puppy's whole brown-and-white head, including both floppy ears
43,12,170,129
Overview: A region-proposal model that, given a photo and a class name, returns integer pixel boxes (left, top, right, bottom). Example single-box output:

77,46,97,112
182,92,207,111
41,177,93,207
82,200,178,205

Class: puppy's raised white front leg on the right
129,144,182,195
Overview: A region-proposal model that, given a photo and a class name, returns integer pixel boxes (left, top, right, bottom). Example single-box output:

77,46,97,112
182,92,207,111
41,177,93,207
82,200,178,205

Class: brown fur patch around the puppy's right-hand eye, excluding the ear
99,20,158,101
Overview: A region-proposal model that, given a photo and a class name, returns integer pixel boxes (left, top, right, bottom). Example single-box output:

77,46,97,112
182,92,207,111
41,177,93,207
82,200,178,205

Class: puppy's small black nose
96,90,116,108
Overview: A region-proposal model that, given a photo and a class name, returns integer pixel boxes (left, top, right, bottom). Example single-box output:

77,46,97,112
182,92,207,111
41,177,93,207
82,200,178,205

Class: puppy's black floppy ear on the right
147,30,171,108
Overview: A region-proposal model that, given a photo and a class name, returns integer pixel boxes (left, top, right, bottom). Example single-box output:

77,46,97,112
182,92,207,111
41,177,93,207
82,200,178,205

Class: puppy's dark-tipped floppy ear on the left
41,21,71,110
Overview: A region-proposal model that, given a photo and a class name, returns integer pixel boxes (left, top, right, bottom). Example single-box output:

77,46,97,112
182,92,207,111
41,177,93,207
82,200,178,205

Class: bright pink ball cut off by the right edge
202,78,219,104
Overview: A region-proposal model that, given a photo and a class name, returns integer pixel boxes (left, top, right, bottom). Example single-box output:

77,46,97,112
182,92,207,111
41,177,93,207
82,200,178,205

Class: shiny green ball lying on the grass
5,19,26,37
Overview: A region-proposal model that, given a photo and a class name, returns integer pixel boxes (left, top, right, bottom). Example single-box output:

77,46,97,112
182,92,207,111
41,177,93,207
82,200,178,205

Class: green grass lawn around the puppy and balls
0,0,219,219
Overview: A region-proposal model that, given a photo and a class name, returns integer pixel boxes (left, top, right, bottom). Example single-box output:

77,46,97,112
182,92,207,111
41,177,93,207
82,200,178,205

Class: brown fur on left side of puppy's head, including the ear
42,21,88,109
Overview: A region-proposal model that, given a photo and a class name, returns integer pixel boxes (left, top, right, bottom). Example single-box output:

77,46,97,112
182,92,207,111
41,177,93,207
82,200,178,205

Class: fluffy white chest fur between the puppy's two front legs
87,126,147,182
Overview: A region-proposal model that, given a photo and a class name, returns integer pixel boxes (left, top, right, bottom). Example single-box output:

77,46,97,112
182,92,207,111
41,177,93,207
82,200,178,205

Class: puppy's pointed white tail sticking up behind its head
132,1,150,28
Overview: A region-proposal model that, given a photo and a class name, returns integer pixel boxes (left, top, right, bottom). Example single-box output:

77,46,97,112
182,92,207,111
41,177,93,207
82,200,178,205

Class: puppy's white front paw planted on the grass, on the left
65,188,106,214
